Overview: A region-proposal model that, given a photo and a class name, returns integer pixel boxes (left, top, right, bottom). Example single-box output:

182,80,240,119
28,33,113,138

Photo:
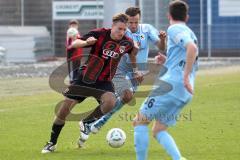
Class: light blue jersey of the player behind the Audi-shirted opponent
117,24,159,73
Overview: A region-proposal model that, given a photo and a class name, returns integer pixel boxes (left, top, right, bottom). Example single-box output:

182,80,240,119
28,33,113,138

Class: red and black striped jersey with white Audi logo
81,28,133,82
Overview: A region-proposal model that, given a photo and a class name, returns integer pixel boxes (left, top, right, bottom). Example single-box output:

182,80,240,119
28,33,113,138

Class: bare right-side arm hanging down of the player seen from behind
184,42,198,94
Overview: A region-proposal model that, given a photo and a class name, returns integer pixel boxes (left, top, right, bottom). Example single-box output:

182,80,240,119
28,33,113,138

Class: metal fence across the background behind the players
0,0,240,57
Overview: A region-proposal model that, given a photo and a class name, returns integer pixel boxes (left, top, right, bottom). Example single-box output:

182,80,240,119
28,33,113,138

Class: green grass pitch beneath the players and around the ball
0,67,240,160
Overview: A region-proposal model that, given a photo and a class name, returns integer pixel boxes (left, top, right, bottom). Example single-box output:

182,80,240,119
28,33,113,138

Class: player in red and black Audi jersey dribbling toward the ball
42,13,140,153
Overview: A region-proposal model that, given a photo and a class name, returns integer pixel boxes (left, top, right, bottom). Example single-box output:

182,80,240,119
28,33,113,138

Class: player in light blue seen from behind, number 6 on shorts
133,0,198,160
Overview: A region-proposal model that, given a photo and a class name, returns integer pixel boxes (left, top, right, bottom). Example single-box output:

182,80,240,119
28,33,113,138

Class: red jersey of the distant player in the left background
66,33,82,61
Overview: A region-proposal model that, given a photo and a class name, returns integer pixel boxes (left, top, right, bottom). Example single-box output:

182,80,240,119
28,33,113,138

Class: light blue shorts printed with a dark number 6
140,94,190,126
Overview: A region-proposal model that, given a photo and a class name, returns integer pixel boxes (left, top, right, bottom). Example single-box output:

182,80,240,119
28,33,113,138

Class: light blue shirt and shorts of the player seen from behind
140,23,197,126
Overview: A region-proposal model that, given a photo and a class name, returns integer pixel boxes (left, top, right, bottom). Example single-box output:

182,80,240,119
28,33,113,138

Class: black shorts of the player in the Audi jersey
63,75,115,102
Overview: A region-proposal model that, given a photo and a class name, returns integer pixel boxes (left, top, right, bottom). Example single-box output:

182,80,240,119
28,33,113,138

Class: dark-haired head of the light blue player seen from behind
169,0,189,21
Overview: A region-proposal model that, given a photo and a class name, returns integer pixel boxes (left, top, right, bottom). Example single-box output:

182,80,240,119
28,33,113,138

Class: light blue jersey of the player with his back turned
160,23,198,102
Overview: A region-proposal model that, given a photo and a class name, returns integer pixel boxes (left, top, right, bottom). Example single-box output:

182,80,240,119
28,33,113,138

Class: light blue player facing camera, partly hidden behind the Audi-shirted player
79,7,166,147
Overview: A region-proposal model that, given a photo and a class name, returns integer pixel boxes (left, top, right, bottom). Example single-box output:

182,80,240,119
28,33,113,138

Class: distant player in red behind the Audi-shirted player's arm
66,19,82,84
